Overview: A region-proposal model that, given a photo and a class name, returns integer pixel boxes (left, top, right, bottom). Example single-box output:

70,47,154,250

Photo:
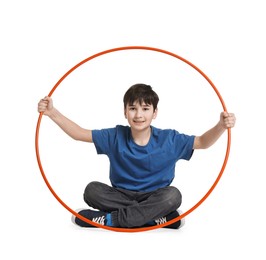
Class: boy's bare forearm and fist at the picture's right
193,112,236,149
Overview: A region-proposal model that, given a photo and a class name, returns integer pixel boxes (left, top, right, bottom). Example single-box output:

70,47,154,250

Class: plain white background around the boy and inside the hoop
0,0,266,259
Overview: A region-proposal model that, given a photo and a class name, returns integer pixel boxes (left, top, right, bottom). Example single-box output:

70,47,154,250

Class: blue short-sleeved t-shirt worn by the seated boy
92,125,194,191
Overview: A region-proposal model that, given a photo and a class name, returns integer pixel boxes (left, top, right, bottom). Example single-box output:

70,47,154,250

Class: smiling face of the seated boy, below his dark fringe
124,101,157,131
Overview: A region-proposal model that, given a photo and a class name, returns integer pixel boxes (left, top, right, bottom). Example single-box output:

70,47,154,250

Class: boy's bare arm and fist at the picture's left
38,97,93,143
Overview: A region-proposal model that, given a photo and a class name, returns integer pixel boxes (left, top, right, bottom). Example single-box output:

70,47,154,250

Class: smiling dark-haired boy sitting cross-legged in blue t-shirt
38,84,235,228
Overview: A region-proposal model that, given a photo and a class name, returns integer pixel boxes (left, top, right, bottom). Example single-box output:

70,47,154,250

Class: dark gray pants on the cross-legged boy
84,181,182,228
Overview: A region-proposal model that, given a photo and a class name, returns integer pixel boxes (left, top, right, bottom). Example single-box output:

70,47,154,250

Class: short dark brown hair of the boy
123,83,159,111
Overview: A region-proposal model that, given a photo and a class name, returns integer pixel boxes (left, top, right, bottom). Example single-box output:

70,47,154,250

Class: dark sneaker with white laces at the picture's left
71,209,107,227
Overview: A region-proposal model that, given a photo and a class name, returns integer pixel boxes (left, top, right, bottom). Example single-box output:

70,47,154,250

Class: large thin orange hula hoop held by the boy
35,46,231,232
